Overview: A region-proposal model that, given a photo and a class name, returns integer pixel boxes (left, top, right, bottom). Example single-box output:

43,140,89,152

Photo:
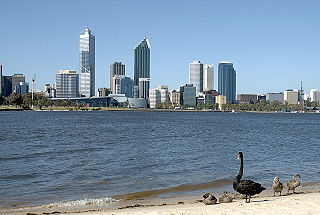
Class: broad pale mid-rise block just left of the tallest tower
56,70,79,98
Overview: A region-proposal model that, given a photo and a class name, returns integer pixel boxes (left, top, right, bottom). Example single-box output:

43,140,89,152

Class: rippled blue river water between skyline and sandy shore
0,111,320,207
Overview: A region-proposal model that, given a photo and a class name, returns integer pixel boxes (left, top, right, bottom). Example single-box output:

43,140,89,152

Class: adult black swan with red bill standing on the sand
233,152,266,203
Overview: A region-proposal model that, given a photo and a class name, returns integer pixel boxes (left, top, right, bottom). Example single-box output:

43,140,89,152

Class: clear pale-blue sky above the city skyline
0,0,320,94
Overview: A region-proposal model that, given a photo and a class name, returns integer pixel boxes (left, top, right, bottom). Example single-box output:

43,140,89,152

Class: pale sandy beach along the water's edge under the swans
0,186,320,215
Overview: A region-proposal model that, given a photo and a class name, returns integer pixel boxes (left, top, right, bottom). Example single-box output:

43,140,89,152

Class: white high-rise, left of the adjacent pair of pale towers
189,61,203,96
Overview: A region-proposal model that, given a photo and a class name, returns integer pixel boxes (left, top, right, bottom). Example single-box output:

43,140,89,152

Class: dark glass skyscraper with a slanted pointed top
134,37,151,98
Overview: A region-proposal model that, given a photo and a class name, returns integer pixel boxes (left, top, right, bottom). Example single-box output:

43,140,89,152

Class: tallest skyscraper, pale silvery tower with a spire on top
80,28,95,97
